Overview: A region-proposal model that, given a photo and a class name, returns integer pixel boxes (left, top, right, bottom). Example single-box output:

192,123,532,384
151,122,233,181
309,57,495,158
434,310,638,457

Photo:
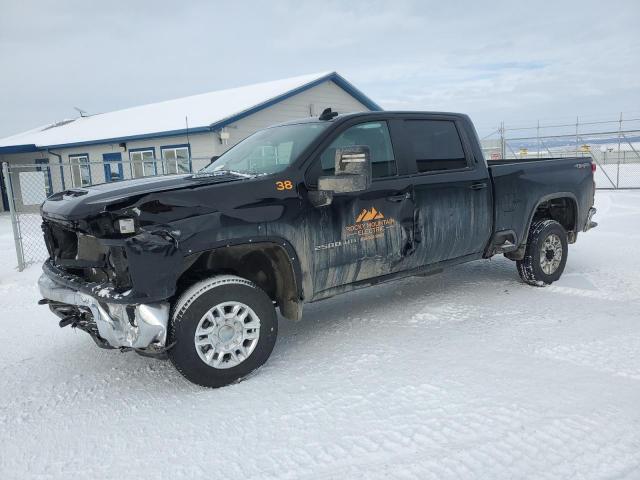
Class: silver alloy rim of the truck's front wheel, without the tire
194,302,260,369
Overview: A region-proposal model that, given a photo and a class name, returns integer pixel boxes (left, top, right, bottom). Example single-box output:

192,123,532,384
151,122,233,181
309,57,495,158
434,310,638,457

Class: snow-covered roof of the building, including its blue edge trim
0,72,379,148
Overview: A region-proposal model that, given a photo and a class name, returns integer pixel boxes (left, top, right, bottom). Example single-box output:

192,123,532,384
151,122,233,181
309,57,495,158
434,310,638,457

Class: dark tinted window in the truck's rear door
404,120,467,172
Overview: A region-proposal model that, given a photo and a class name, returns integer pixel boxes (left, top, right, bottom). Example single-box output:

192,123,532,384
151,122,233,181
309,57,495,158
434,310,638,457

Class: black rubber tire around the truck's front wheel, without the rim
168,275,278,388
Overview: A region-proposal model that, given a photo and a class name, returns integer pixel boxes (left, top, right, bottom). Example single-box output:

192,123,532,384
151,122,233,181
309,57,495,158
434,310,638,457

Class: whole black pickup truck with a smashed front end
39,109,596,387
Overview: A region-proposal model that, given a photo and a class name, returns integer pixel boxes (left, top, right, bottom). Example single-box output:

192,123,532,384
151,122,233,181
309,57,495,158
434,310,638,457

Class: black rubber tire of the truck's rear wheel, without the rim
516,219,569,287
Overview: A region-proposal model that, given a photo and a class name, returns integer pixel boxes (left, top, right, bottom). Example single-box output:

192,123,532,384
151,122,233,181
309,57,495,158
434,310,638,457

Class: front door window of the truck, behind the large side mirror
320,122,397,178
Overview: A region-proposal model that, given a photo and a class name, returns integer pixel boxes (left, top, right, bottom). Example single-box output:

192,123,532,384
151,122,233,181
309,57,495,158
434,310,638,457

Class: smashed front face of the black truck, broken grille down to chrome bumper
38,219,182,357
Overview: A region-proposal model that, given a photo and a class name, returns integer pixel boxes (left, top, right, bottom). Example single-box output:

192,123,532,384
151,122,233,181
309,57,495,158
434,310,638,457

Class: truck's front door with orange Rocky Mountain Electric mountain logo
304,120,414,298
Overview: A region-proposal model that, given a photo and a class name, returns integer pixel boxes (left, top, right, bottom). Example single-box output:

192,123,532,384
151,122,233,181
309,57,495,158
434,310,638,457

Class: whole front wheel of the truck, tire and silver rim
168,275,278,387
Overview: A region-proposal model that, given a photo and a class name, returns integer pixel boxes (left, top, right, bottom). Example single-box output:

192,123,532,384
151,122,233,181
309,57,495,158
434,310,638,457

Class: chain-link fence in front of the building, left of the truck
2,157,210,271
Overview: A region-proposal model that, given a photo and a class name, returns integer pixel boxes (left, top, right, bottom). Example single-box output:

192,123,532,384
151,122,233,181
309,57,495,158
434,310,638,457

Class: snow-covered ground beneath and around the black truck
0,191,640,480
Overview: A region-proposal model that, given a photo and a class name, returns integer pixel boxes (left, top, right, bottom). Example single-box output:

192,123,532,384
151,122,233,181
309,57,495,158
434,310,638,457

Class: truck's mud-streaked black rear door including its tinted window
402,115,492,265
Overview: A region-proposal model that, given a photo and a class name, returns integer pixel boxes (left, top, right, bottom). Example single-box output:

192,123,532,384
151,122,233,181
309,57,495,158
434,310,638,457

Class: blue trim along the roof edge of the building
0,72,382,152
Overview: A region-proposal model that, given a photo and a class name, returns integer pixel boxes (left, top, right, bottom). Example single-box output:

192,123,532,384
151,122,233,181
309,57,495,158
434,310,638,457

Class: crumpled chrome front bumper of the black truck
38,272,169,350
